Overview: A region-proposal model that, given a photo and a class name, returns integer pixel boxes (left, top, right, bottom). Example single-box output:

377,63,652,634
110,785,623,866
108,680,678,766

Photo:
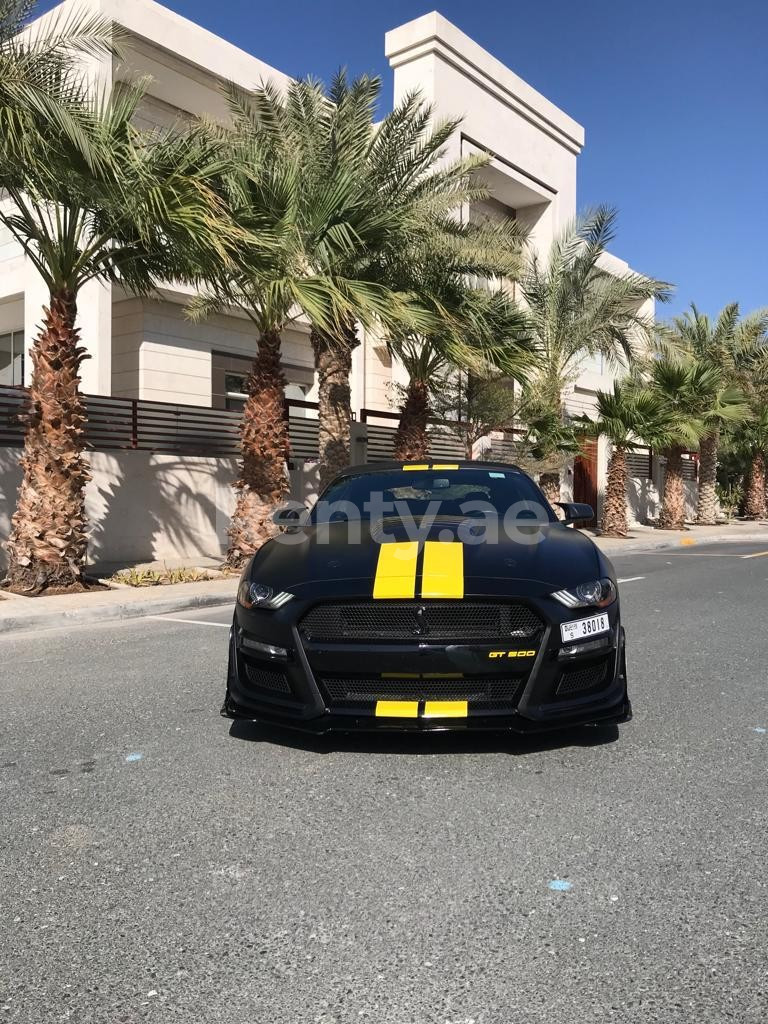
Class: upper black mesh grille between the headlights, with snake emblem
300,601,544,643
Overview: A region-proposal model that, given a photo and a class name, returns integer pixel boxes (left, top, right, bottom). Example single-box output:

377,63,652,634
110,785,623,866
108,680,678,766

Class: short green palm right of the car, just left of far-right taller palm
649,356,750,529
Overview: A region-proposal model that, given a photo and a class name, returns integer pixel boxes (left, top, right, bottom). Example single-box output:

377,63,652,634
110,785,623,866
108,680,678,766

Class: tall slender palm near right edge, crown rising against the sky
657,302,768,525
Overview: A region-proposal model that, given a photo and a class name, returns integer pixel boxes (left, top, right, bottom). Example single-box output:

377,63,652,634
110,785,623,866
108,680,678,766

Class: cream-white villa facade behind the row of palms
0,0,671,528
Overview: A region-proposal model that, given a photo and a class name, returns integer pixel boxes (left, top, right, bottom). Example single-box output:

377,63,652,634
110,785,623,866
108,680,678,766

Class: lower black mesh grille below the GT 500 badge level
319,675,525,711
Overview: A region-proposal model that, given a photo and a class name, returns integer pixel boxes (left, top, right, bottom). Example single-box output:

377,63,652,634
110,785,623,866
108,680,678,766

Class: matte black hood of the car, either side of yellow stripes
250,518,601,598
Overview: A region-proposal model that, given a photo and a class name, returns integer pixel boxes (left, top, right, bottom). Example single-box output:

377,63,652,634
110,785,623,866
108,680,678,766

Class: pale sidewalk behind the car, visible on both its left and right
0,522,768,635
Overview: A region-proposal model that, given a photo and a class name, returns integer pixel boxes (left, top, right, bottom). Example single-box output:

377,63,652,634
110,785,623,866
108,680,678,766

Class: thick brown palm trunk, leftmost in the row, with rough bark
6,291,90,593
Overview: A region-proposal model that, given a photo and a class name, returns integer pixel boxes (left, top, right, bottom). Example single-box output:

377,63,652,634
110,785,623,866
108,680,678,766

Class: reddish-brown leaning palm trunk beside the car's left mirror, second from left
226,331,290,568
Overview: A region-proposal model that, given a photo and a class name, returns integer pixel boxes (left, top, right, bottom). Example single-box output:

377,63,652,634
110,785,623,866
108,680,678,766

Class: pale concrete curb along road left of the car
0,591,234,634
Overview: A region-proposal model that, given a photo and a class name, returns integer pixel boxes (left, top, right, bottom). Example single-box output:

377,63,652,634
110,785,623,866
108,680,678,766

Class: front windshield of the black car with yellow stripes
312,466,556,522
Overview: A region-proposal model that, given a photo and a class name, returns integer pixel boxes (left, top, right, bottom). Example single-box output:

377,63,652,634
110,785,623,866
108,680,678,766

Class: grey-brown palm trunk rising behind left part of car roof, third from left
310,325,359,487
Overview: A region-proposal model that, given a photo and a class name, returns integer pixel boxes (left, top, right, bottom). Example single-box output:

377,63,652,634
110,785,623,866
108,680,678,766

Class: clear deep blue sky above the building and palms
70,0,768,314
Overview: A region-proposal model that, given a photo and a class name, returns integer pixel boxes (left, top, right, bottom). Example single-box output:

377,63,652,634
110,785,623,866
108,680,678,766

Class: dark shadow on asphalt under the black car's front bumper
229,721,618,757
